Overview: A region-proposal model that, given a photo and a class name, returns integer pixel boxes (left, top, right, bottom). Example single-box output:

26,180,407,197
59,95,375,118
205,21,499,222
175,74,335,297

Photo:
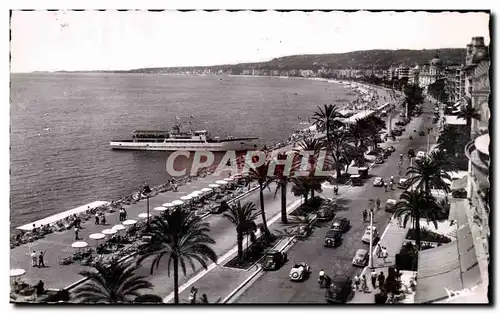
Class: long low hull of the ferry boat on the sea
110,141,256,152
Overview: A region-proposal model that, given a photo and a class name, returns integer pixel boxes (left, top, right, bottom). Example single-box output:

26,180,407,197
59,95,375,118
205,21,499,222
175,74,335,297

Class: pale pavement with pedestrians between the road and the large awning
350,219,411,303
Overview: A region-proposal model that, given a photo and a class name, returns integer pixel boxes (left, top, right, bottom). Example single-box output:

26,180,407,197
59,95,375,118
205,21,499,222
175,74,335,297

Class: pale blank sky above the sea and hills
10,10,490,73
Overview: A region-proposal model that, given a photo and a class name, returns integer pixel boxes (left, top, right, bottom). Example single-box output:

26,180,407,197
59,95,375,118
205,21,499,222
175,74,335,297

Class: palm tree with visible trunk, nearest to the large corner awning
394,191,441,251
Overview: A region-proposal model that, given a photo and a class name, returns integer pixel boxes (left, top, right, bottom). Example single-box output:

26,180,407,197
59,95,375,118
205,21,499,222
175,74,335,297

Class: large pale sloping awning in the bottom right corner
415,225,481,303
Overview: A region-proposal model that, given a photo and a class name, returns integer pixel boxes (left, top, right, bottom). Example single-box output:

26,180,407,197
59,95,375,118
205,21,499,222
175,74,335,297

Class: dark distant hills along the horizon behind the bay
52,48,465,74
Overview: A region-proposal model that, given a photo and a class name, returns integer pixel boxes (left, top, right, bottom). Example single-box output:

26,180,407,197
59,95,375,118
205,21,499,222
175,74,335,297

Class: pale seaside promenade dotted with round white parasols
10,168,256,289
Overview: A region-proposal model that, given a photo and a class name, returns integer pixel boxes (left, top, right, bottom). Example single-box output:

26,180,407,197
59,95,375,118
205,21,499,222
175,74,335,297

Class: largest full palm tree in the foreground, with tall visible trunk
137,209,217,304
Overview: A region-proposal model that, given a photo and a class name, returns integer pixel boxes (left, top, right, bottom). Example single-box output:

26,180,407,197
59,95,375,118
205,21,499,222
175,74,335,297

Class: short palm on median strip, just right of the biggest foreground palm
223,201,259,261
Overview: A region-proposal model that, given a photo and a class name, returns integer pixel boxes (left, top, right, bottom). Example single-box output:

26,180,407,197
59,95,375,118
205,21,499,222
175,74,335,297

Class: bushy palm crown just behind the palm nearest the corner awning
406,157,451,195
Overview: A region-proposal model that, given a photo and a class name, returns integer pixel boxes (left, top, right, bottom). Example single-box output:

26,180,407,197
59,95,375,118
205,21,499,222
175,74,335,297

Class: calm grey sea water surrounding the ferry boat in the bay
10,74,352,227
